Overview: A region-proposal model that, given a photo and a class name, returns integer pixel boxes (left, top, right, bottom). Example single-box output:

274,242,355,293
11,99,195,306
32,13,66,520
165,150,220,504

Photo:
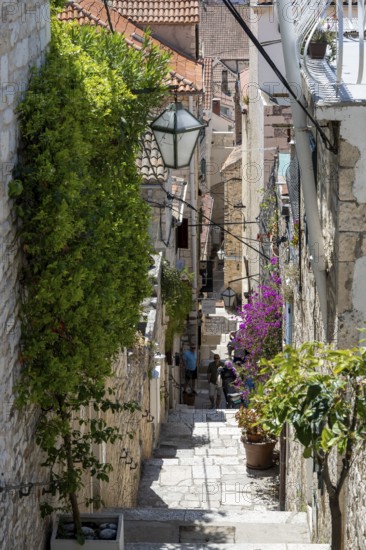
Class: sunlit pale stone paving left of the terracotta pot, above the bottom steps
137,406,278,512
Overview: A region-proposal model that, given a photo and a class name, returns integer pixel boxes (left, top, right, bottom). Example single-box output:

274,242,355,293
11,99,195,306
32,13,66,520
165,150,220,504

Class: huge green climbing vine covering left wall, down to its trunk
9,20,167,542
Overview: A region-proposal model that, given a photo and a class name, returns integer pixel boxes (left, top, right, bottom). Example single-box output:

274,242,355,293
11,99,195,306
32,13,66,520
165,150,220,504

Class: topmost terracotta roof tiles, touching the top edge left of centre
109,0,199,25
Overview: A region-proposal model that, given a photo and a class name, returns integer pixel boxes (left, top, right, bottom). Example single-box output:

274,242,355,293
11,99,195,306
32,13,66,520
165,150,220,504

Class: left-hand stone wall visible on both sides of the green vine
0,11,169,550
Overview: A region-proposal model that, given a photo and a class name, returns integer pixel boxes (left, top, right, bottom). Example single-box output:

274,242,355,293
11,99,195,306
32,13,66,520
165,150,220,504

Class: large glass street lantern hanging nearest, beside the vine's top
150,102,205,168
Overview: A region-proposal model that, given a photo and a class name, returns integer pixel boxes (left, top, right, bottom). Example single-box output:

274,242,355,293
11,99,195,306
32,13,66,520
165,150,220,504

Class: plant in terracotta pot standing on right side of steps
235,400,276,470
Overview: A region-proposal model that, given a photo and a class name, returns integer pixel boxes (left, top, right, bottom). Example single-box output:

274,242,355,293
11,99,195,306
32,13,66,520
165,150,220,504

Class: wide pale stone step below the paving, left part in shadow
118,508,314,550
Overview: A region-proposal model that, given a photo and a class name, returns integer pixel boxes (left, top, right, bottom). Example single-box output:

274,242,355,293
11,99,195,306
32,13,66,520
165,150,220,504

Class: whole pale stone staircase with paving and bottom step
109,408,330,550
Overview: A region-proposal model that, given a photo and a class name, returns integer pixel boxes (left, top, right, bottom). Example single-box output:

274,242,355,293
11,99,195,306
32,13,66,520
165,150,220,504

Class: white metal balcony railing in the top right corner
292,0,366,85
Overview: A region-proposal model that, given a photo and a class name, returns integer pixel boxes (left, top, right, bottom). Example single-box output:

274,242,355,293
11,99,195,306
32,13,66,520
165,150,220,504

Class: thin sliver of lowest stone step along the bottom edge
124,542,330,550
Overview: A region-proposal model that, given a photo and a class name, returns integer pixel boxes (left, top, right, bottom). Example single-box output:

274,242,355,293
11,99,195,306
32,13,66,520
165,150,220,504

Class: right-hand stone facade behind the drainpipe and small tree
287,89,366,550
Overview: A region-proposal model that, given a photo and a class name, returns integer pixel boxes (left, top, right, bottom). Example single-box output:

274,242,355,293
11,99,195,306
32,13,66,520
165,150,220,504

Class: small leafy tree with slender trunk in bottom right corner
261,342,366,550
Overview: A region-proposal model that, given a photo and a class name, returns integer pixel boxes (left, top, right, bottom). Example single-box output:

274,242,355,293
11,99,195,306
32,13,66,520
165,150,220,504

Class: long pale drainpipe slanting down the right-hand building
278,0,327,333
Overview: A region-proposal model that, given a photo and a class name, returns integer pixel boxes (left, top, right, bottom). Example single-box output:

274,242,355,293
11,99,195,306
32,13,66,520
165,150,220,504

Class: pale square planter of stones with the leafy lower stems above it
26,384,140,550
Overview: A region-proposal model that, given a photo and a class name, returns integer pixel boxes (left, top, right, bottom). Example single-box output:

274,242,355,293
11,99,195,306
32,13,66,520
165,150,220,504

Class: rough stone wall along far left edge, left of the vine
0,0,50,550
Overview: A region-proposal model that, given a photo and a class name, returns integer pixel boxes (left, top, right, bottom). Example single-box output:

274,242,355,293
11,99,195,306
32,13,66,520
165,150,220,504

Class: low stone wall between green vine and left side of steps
100,255,170,507
